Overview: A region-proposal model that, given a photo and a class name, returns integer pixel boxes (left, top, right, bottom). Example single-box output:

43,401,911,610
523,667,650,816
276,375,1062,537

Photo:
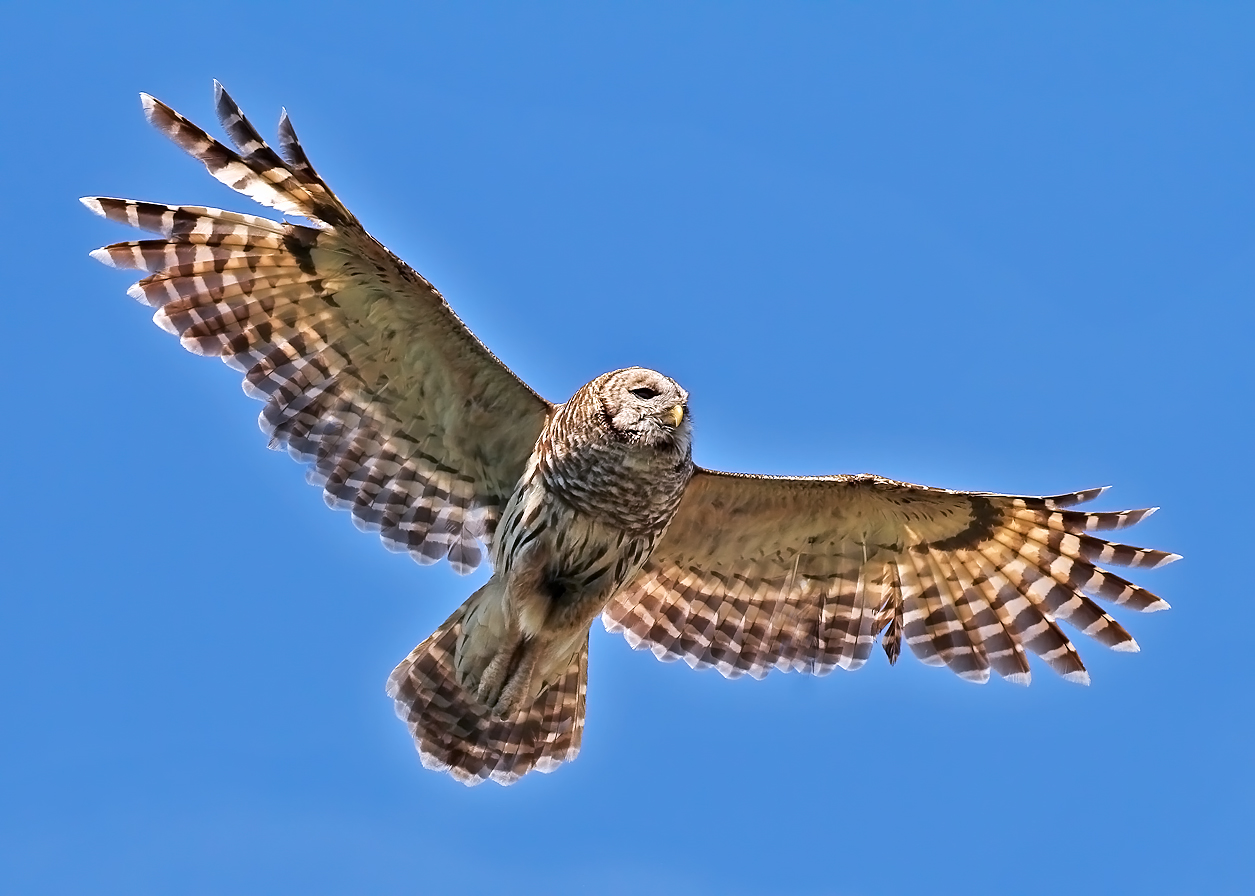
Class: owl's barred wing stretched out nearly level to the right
602,469,1178,684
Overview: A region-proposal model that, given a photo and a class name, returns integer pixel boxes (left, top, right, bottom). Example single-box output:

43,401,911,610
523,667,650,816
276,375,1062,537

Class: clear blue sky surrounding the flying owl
0,3,1255,895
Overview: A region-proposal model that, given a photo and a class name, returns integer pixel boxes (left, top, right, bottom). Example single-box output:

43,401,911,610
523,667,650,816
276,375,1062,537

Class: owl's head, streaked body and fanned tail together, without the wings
371,368,694,783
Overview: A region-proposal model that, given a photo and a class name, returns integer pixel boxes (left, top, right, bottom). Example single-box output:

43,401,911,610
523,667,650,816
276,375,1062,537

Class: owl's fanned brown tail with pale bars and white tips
388,582,589,786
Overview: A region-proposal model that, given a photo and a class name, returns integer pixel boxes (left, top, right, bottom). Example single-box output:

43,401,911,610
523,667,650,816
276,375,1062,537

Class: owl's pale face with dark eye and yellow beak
597,368,693,454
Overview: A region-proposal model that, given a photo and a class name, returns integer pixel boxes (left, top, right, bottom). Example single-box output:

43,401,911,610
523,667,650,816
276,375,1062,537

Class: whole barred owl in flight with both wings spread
83,84,1177,783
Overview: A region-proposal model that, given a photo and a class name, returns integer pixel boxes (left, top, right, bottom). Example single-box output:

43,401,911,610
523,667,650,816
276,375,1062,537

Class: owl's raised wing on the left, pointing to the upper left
83,82,551,572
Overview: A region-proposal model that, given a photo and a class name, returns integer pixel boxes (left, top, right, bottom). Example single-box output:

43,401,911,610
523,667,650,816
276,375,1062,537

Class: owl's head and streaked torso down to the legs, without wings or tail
456,368,693,717
